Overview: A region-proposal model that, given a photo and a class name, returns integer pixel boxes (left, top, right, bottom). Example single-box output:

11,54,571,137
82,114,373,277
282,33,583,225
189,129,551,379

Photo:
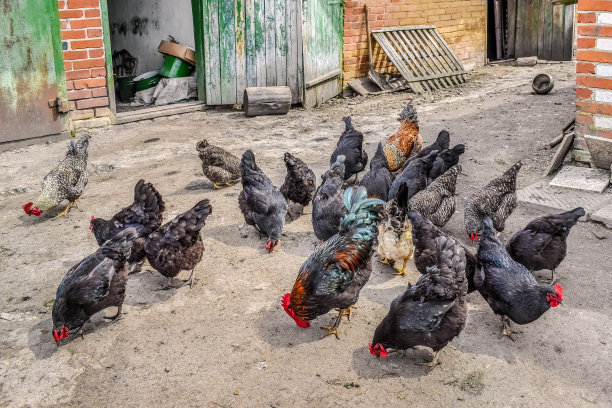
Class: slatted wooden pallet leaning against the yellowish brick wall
372,26,466,94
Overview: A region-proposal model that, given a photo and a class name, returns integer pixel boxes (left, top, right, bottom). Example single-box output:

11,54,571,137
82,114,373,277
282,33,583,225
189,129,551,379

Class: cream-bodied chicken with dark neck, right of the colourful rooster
376,200,414,275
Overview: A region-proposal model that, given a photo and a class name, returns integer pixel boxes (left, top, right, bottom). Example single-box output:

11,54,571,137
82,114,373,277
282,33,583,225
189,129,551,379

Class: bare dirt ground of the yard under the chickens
0,64,612,407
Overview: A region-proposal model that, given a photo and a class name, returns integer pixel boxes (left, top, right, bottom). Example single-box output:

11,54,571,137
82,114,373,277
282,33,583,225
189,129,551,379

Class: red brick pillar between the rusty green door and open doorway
58,0,112,127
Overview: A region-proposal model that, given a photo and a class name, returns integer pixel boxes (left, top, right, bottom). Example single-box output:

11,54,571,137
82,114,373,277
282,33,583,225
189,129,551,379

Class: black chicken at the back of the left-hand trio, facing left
89,179,166,270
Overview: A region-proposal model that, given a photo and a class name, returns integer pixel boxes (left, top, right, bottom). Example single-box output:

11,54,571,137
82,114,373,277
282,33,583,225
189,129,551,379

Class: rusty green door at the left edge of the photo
0,0,66,142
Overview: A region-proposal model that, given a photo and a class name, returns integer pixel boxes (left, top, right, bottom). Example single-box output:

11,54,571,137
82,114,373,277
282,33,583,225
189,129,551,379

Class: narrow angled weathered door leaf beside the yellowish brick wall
302,0,344,108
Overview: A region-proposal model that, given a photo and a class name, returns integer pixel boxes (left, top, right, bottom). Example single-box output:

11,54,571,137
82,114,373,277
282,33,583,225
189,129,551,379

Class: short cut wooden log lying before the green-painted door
242,86,291,116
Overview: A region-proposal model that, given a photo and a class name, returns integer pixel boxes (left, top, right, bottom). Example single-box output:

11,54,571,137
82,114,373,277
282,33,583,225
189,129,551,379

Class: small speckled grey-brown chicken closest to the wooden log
196,139,240,188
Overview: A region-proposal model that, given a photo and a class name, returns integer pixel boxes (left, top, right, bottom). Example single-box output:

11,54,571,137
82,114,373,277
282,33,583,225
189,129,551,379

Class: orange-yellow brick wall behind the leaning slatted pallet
344,0,487,82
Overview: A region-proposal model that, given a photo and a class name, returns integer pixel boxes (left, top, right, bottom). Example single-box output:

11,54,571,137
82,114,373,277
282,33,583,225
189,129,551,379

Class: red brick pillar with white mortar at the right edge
574,0,612,162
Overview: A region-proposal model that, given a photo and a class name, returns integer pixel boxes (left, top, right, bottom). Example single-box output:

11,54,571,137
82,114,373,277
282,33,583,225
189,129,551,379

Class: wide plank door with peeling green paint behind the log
192,0,303,105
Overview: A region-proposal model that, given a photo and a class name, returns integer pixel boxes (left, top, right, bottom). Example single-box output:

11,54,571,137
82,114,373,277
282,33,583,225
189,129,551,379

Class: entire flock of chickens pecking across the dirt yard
23,103,584,367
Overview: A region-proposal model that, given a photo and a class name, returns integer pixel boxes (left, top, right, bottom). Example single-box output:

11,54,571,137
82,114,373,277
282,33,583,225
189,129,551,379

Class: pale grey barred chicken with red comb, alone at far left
23,135,90,217
